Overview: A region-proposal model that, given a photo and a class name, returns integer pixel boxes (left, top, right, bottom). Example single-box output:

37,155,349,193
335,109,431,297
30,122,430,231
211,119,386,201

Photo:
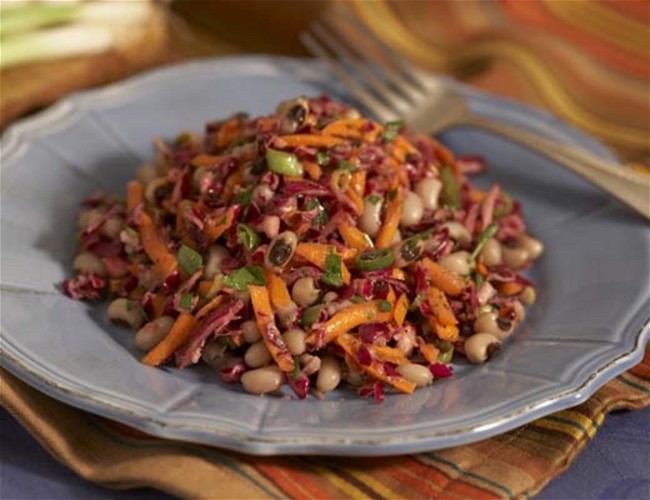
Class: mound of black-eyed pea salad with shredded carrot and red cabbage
63,96,543,400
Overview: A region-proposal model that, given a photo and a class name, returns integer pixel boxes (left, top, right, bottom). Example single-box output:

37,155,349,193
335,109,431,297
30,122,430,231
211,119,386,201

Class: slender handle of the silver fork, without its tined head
455,113,650,219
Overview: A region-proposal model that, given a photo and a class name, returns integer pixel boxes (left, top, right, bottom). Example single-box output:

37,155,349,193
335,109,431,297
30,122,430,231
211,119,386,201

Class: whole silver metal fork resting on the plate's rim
301,12,650,219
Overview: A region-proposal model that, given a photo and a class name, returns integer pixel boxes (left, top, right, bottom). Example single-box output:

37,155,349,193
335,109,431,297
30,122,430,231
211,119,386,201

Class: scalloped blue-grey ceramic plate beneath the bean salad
1,57,650,455
